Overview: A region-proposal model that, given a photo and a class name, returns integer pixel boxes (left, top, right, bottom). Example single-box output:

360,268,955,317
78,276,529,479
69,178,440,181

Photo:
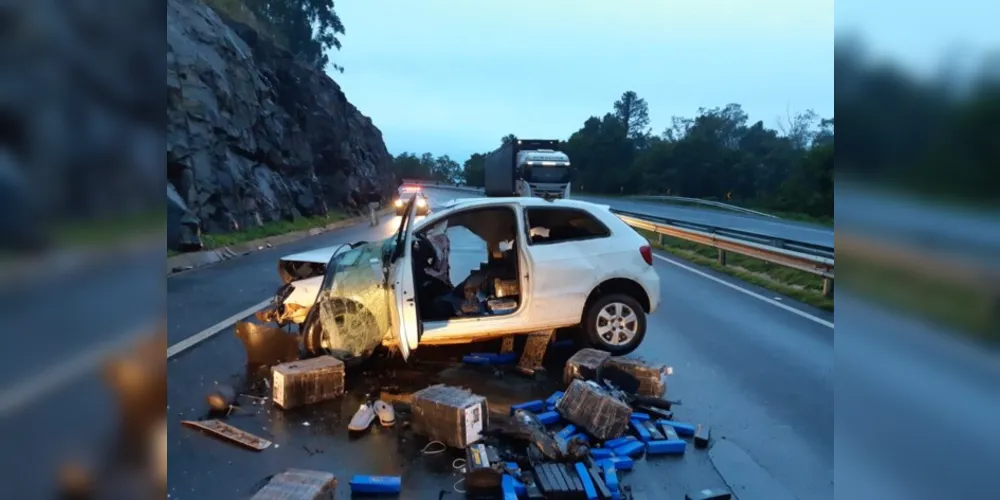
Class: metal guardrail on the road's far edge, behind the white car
406,183,834,297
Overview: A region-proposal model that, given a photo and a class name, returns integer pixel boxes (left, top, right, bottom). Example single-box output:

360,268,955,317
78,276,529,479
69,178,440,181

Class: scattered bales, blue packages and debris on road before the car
212,332,708,500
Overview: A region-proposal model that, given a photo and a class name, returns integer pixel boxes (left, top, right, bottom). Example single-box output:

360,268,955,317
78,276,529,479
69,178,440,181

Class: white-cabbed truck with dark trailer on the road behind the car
484,139,572,199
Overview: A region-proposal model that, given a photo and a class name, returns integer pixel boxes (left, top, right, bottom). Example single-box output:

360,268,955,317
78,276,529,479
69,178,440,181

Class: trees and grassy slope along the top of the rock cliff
206,0,344,73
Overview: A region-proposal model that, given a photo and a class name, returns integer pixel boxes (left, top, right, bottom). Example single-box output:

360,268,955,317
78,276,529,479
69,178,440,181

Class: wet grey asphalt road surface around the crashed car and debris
167,190,833,499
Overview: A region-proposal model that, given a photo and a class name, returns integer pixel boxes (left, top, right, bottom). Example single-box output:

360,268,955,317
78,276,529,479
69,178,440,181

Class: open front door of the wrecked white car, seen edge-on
389,192,423,359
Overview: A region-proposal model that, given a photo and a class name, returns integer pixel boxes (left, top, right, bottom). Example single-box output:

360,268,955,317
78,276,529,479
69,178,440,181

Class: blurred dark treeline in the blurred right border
834,36,1000,206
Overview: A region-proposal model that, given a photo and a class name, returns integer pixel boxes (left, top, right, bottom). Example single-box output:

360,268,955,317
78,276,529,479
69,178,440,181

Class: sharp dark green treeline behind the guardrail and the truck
463,92,834,217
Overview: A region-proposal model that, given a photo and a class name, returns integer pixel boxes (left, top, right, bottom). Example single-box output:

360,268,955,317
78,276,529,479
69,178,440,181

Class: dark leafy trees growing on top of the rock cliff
245,0,344,73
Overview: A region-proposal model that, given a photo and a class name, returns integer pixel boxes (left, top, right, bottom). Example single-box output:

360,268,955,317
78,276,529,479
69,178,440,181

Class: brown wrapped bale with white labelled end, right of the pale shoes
410,384,489,448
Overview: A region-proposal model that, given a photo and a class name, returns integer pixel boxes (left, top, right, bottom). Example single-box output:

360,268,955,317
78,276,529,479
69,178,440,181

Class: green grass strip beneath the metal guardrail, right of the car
638,230,833,311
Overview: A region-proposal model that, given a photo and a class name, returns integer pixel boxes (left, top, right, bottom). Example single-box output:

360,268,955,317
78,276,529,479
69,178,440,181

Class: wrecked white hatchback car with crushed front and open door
259,197,660,361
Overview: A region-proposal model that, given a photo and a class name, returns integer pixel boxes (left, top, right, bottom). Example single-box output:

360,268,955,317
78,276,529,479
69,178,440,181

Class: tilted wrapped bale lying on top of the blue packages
556,380,632,440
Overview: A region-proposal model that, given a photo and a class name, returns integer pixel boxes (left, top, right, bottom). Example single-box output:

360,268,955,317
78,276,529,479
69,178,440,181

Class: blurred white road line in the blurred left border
0,323,156,418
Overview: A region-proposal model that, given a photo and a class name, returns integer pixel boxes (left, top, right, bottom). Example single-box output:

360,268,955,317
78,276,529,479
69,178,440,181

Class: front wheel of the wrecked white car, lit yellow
302,299,382,367
